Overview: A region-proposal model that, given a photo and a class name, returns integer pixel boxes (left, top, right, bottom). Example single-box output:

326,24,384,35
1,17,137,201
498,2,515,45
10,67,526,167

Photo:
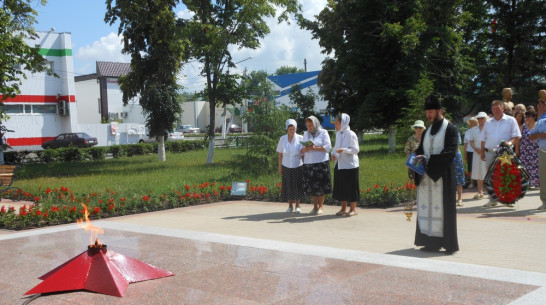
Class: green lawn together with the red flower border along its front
0,137,415,229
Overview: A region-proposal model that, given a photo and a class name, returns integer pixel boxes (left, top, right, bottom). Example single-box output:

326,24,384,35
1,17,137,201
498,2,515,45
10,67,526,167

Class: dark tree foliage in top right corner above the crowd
481,0,546,105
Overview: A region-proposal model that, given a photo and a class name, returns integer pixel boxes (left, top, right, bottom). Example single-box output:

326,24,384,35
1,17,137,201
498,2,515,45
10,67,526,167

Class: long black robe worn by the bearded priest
415,119,459,252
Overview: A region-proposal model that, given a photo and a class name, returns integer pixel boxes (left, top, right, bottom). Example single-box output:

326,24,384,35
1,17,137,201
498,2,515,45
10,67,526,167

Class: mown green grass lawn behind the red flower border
14,135,407,194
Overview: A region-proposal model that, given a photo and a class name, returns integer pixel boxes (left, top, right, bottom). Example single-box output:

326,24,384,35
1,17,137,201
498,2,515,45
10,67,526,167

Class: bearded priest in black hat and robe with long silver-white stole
415,95,459,255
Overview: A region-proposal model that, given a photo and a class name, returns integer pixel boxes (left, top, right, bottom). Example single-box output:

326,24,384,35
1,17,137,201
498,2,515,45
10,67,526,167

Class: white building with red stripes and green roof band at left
2,31,78,150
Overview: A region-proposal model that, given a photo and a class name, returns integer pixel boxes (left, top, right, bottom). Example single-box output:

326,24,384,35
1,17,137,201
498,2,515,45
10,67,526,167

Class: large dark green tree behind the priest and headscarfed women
300,0,478,151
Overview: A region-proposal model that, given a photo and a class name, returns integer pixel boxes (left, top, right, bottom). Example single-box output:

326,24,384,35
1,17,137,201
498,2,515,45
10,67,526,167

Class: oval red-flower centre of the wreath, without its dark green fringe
493,158,521,204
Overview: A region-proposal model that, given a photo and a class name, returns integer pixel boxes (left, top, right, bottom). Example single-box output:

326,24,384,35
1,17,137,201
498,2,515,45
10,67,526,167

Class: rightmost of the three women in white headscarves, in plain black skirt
332,113,360,216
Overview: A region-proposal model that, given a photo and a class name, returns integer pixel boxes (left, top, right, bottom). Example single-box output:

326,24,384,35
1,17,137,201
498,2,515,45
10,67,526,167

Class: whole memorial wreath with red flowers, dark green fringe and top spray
484,141,529,204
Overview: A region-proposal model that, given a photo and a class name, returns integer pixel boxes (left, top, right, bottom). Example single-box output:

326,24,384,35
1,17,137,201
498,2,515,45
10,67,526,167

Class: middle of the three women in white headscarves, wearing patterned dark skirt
301,116,332,215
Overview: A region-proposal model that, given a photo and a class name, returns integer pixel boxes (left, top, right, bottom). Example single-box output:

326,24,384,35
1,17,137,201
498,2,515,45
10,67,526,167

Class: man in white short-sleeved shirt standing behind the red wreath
481,100,521,207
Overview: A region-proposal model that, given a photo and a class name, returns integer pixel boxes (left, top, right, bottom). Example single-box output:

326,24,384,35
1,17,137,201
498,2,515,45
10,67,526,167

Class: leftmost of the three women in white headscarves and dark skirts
277,119,305,213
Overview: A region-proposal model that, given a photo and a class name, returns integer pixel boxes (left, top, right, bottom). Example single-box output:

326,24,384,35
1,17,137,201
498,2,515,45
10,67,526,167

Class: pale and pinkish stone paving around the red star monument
0,190,546,305
